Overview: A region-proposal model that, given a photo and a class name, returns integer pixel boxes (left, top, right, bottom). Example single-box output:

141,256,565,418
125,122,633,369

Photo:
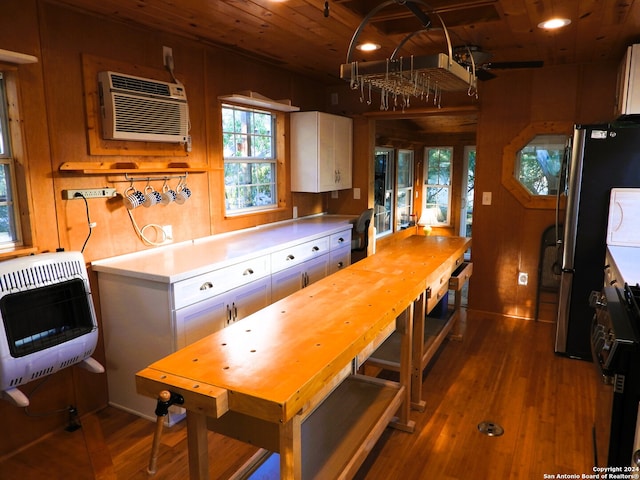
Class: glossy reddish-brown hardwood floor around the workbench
0,312,596,480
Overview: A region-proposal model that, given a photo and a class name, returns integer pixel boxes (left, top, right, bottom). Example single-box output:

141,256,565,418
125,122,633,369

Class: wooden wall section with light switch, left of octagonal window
469,72,531,312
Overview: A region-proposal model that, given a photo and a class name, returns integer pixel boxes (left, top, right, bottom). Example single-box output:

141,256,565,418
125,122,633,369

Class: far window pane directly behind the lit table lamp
423,147,453,225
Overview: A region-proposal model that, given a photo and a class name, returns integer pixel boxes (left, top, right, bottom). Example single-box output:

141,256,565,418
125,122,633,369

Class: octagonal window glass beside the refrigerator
514,134,568,195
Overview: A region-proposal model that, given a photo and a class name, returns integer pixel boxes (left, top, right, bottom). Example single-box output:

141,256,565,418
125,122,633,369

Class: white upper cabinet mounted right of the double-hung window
291,112,353,193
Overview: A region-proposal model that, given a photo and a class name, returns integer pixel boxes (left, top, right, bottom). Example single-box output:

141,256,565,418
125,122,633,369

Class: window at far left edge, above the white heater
0,72,22,248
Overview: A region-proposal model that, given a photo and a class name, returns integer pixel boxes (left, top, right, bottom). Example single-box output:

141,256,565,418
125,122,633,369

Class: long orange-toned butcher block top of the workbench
137,236,467,423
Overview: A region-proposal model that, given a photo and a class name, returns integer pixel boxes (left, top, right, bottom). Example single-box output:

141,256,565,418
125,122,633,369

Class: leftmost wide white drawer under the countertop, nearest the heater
173,255,270,309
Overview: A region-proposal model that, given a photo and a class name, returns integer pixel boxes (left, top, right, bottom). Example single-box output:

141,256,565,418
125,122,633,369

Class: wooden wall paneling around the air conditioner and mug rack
41,4,210,261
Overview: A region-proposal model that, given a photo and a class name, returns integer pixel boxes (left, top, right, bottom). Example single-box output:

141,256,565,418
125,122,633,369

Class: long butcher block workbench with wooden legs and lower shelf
136,236,468,479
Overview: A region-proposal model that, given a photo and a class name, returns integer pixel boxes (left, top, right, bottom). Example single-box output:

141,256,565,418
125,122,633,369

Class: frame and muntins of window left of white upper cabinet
220,101,278,217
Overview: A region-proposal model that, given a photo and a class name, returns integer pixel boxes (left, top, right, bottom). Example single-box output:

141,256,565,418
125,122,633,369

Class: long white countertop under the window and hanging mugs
91,215,354,283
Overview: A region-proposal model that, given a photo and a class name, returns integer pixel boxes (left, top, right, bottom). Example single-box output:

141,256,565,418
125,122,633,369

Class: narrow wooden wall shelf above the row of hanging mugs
60,162,208,175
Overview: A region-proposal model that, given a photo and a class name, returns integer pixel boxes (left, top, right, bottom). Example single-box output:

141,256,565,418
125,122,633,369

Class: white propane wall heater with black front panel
0,252,104,407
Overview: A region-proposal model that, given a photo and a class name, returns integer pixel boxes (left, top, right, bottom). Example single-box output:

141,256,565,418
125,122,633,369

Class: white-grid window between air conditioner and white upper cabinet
222,104,278,214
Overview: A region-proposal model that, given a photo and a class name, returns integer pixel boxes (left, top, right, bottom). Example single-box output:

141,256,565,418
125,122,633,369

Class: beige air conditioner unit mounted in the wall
98,72,189,143
